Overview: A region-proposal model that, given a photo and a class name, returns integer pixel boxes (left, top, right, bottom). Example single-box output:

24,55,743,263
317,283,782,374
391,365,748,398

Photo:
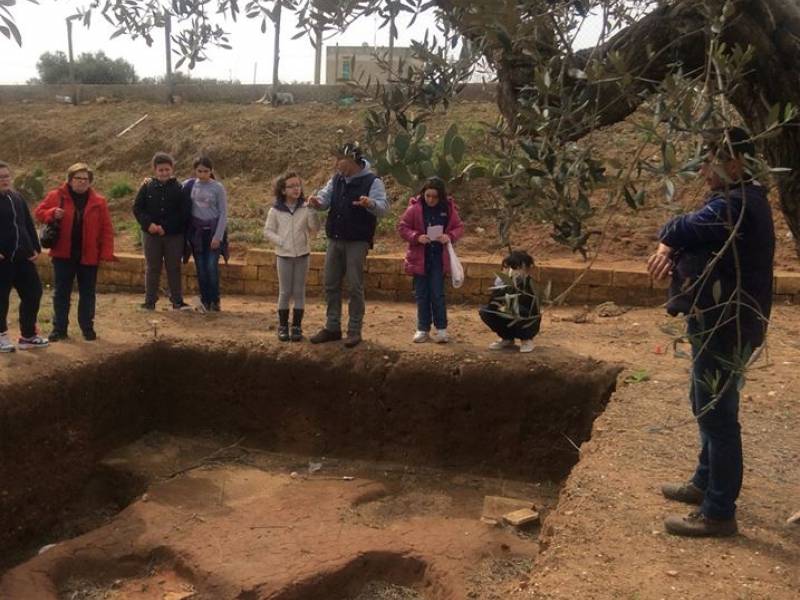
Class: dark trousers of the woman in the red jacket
53,258,97,333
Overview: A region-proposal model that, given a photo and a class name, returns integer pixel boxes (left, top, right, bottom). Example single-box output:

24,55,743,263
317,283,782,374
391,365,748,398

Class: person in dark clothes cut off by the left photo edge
0,161,47,353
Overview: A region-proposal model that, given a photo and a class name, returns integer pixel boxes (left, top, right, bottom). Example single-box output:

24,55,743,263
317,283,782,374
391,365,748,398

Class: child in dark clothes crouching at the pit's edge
478,250,542,352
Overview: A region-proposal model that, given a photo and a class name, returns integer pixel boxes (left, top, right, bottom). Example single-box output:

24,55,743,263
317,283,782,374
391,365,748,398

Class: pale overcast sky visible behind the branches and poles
0,0,590,83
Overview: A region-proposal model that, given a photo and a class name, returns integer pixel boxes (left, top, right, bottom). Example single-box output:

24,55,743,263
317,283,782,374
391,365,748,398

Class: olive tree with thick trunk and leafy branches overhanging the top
0,0,800,253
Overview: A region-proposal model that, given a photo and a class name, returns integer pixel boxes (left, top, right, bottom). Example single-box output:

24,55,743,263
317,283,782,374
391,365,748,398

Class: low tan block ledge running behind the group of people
32,248,800,306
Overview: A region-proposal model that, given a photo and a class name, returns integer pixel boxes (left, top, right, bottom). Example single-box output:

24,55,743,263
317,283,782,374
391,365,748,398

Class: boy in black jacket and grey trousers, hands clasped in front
133,152,192,310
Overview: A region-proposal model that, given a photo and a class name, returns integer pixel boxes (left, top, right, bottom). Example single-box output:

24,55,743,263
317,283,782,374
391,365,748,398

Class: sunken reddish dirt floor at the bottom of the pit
5,432,558,600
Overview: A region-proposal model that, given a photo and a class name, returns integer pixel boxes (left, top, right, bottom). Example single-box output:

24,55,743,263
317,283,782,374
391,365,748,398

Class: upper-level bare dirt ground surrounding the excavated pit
0,295,800,600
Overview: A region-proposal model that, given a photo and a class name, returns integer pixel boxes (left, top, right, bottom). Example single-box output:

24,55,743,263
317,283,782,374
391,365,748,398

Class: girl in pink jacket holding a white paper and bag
397,177,464,343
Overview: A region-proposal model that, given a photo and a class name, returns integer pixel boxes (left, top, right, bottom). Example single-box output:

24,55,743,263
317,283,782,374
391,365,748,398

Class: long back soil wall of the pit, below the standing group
155,347,616,479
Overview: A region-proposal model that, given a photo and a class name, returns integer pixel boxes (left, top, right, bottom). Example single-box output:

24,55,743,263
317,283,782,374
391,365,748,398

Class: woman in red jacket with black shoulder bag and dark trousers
36,163,114,342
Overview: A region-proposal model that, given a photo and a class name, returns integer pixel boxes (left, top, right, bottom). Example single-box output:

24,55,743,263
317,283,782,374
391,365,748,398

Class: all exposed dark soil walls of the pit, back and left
0,343,618,572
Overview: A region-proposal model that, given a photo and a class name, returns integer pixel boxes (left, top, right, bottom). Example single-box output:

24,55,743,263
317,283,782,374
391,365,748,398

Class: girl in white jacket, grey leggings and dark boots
264,172,319,342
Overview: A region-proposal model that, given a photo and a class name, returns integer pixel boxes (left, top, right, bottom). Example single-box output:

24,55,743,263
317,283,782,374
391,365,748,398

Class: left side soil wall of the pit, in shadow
0,351,154,569
